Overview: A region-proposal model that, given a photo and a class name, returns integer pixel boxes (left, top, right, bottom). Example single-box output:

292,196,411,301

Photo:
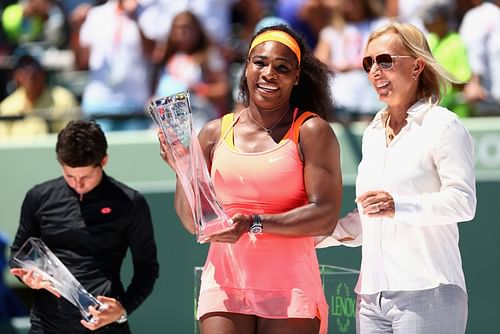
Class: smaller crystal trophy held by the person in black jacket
13,237,106,322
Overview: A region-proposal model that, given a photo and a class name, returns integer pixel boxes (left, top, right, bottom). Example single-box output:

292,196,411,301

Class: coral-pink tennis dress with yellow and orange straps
197,110,328,333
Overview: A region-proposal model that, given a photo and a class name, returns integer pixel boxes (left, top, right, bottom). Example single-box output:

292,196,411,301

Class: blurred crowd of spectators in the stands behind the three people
0,0,500,138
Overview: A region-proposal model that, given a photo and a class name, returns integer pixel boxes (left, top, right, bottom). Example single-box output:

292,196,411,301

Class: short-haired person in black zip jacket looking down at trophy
11,120,158,334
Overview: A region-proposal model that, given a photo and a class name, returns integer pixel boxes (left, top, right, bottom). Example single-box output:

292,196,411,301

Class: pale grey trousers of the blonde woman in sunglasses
356,285,468,334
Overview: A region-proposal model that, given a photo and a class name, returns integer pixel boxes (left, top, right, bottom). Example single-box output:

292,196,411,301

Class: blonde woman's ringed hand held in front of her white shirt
356,190,395,218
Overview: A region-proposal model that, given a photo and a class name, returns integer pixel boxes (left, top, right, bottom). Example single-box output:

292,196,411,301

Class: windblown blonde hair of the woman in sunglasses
367,20,461,104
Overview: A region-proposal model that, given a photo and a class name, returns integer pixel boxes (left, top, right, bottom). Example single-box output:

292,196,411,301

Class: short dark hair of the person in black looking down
56,120,108,168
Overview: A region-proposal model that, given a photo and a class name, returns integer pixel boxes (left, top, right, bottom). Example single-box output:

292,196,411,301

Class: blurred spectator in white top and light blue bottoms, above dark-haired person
72,0,155,132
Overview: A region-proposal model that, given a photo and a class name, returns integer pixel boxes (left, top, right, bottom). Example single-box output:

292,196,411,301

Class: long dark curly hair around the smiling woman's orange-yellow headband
239,24,333,119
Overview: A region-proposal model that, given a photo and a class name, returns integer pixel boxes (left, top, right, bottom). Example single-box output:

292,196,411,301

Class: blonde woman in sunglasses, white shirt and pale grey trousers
318,22,476,334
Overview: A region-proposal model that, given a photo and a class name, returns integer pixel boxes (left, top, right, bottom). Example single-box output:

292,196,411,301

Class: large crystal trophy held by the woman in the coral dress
148,91,232,243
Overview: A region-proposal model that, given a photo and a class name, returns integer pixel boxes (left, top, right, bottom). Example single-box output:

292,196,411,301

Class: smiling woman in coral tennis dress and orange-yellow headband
159,25,342,334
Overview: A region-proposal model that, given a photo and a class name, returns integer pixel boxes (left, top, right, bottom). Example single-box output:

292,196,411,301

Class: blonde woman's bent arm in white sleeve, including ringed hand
356,120,476,226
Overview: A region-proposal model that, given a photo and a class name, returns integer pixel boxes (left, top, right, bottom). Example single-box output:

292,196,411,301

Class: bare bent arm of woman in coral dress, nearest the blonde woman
262,117,342,237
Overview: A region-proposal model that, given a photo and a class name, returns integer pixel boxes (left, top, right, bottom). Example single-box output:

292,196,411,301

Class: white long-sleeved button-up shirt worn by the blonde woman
355,101,476,294
